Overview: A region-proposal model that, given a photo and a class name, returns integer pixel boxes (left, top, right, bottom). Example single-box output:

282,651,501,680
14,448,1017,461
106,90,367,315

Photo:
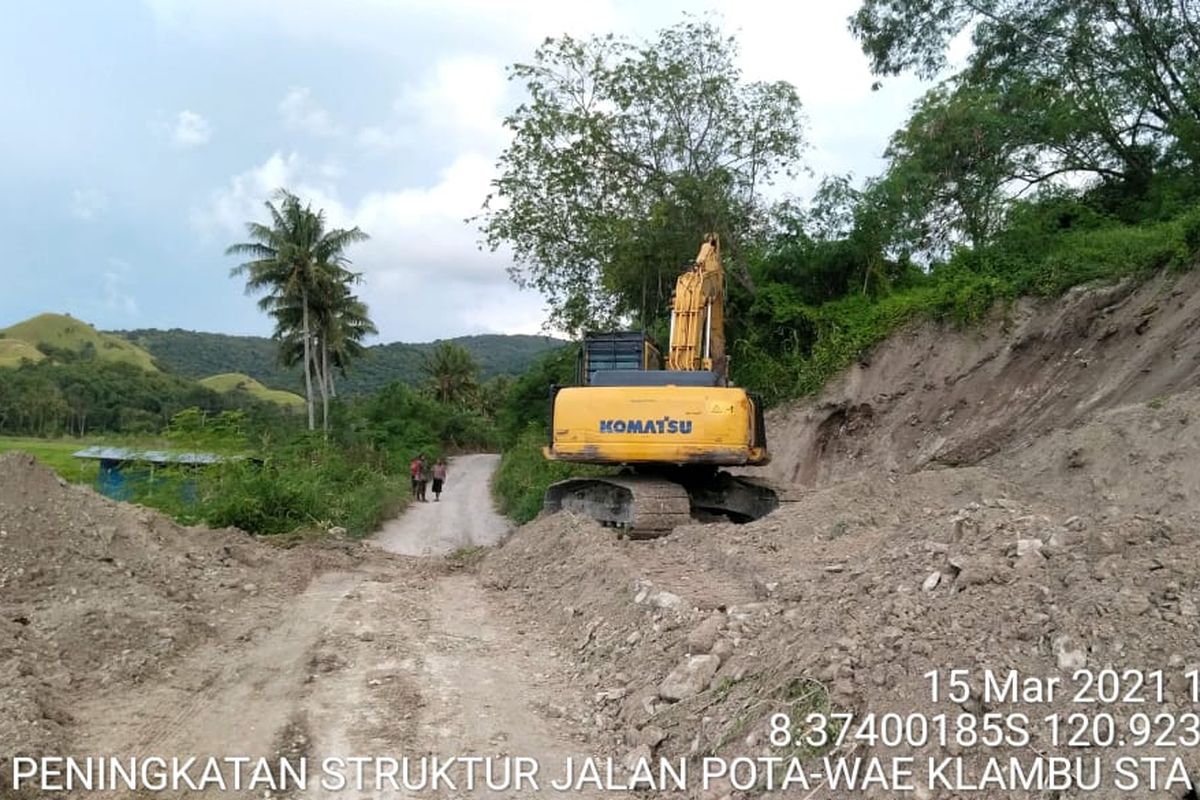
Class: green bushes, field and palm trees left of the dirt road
0,192,530,536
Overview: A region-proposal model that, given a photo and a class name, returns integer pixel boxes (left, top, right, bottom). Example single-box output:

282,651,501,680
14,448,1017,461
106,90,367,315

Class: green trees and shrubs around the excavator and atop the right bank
481,10,1200,521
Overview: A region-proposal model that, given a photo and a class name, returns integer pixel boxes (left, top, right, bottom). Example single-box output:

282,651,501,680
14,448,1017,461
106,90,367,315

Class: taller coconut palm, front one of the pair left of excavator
226,190,367,431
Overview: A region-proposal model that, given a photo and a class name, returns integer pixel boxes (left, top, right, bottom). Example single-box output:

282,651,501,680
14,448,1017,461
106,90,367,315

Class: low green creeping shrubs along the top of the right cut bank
732,203,1200,402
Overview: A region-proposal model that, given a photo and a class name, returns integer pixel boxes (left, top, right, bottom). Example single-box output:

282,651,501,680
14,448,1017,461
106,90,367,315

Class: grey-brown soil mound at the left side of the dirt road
0,453,326,781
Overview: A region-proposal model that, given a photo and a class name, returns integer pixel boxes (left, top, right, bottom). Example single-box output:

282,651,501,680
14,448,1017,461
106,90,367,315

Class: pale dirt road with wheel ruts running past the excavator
63,456,597,799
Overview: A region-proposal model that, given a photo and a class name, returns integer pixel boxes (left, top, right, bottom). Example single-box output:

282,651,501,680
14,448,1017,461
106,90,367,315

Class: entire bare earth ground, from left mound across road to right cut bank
7,276,1200,800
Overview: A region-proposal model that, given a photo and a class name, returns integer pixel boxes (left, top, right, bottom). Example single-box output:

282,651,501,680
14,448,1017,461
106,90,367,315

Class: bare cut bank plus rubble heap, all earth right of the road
484,275,1200,799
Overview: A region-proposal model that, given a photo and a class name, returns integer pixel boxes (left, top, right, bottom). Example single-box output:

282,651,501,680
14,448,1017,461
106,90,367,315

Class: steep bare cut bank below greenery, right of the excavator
763,272,1200,496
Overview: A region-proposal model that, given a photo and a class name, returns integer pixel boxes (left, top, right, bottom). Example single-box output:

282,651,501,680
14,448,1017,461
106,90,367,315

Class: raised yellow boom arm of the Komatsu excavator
667,234,728,386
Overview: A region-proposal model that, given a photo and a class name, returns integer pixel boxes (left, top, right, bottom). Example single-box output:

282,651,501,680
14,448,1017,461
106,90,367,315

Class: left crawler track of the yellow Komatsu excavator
545,475,691,539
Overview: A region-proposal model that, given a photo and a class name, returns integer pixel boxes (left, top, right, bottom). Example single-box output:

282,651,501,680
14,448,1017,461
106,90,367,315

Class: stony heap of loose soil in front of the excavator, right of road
484,461,1200,798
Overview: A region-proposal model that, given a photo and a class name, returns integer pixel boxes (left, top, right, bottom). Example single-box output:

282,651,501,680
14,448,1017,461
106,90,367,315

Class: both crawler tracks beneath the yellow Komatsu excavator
545,473,780,539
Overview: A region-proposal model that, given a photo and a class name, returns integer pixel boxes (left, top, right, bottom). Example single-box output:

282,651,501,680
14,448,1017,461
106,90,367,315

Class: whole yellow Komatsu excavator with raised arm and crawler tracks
544,234,779,539
